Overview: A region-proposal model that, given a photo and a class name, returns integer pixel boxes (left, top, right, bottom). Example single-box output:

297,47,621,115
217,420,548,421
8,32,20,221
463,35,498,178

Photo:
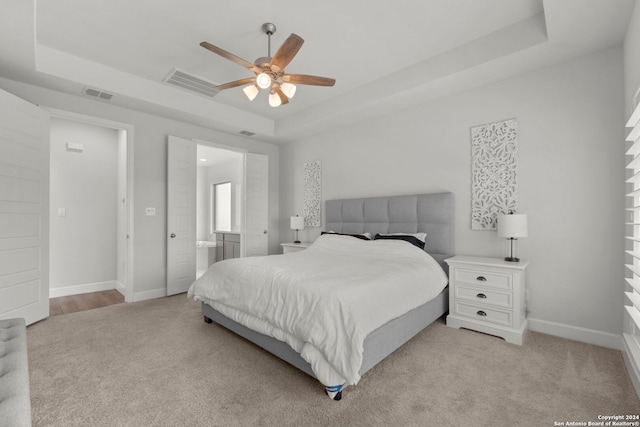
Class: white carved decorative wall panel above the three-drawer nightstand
471,119,518,230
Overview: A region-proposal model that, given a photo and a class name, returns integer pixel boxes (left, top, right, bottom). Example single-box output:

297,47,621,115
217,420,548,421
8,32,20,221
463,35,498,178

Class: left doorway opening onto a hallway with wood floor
49,110,133,302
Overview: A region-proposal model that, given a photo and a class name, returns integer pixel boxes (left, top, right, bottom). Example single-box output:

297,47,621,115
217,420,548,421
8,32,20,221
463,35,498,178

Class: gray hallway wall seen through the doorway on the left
49,118,118,295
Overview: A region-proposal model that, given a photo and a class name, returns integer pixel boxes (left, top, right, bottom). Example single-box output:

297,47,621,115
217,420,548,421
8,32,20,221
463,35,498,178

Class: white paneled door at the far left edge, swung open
0,90,49,324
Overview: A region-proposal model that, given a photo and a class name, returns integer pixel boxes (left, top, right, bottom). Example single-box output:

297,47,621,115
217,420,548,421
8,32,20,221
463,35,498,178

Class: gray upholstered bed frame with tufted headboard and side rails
202,193,454,400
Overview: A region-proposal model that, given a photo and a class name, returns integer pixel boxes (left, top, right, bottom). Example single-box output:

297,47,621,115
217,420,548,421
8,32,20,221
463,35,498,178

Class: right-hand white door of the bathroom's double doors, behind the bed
241,153,269,256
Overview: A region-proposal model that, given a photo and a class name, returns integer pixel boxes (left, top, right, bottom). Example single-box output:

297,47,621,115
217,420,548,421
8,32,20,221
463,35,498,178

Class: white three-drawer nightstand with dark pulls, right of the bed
445,256,529,345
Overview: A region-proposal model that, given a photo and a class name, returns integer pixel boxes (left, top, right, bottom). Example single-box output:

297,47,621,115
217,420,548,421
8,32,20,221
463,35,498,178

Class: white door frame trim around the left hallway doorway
40,110,135,302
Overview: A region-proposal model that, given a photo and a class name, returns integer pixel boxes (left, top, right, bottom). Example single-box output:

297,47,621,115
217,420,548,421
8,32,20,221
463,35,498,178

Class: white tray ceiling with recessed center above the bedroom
0,0,634,142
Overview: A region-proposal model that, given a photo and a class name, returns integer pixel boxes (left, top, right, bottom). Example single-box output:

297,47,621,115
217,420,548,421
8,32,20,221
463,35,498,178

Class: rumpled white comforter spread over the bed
188,235,447,385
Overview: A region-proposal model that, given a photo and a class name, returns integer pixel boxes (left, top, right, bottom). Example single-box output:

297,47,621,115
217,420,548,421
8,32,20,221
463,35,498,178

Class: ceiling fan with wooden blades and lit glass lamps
200,22,336,107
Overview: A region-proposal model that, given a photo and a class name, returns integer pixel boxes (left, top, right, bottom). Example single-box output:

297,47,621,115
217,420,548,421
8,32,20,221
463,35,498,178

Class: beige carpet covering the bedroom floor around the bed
28,294,640,426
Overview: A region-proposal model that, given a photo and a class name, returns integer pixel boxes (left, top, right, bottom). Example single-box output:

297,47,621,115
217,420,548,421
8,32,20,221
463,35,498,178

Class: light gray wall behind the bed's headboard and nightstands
280,47,624,346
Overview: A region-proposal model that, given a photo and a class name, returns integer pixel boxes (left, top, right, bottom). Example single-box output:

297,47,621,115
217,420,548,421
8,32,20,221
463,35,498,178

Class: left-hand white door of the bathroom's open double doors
167,135,197,295
